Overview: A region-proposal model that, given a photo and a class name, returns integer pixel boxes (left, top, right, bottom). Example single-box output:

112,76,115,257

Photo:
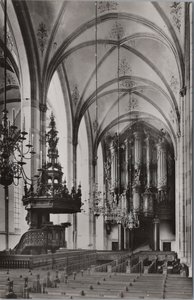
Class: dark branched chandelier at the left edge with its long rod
0,0,35,250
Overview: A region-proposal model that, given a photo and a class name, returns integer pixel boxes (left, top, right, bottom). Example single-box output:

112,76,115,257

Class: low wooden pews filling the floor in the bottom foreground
0,268,192,299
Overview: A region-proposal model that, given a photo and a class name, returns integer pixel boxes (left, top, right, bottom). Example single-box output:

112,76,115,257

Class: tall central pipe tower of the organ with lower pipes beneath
133,131,142,212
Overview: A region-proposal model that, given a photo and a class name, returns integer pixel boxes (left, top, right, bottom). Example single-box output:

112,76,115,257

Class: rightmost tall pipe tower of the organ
157,137,167,202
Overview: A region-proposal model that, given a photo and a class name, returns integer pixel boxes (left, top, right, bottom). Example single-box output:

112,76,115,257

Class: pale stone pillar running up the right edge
178,2,193,276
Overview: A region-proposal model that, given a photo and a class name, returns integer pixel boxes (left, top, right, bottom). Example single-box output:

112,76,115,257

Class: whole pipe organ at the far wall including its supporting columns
101,124,175,250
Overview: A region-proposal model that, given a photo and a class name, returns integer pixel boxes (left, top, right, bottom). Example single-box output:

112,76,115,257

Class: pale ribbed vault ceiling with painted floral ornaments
0,0,185,154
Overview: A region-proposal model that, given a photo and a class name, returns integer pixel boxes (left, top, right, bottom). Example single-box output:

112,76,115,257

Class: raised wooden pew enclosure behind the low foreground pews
0,250,188,276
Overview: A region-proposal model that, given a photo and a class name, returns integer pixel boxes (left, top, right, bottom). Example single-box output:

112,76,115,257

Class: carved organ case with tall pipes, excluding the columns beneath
105,125,174,223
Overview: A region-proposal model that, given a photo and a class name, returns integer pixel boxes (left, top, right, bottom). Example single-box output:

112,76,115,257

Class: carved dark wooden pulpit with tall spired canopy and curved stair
15,114,81,254
